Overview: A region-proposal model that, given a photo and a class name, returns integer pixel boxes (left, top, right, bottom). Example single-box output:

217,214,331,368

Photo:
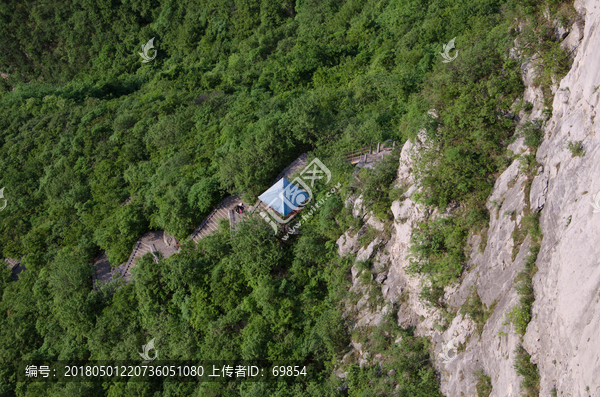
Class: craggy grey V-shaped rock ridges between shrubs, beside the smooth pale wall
388,134,529,397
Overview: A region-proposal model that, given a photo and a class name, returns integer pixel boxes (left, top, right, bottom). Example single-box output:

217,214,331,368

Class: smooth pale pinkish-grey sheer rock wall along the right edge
525,0,600,396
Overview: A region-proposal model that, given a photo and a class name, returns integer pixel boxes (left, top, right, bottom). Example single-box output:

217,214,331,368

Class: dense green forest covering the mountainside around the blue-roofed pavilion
0,0,571,397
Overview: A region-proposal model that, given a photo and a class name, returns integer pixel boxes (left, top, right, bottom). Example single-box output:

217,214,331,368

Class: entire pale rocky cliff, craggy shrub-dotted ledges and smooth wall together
338,0,600,397
